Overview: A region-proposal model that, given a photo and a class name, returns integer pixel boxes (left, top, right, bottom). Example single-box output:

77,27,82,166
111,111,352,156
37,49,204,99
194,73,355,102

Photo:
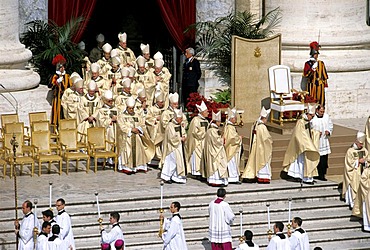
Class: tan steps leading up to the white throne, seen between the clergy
238,124,357,180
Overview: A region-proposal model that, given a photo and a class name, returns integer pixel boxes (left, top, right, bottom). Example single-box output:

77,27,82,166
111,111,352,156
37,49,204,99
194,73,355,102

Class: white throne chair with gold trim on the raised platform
268,65,305,126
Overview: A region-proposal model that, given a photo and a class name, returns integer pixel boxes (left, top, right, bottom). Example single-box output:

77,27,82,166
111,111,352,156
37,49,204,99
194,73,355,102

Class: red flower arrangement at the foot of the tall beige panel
186,92,229,121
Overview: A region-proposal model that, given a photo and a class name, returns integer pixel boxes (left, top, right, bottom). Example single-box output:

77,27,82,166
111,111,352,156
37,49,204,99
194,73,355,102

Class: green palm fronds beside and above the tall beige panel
185,8,281,86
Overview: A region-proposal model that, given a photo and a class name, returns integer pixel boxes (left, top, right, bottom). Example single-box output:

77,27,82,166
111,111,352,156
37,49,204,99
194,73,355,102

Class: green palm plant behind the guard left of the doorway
21,17,83,85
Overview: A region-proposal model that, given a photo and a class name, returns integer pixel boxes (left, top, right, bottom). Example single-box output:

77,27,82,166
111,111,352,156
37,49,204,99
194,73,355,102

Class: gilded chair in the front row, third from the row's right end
31,131,63,176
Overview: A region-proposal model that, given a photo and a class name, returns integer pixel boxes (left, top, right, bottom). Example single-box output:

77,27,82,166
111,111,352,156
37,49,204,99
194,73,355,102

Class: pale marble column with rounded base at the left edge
0,0,40,124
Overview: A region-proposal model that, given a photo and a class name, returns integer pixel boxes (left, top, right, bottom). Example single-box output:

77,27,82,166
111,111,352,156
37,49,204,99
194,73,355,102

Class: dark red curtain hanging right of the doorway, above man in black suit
157,0,196,51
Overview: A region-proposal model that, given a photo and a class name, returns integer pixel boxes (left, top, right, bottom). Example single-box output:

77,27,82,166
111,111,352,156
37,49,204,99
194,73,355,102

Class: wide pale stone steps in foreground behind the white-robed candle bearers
0,170,370,250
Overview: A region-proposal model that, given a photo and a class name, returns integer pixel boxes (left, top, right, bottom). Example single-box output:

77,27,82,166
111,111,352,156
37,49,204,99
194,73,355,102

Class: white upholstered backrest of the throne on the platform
269,65,293,99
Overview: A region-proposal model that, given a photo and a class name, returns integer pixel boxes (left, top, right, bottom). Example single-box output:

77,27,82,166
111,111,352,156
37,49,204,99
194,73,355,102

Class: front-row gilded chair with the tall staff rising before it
4,133,35,178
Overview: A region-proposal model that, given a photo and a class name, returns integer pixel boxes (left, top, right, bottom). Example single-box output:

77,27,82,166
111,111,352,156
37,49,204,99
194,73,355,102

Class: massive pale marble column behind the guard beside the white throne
266,0,370,119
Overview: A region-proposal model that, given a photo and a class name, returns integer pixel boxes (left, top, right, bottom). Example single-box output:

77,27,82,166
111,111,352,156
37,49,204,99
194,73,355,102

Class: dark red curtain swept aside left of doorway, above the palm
48,0,96,43
